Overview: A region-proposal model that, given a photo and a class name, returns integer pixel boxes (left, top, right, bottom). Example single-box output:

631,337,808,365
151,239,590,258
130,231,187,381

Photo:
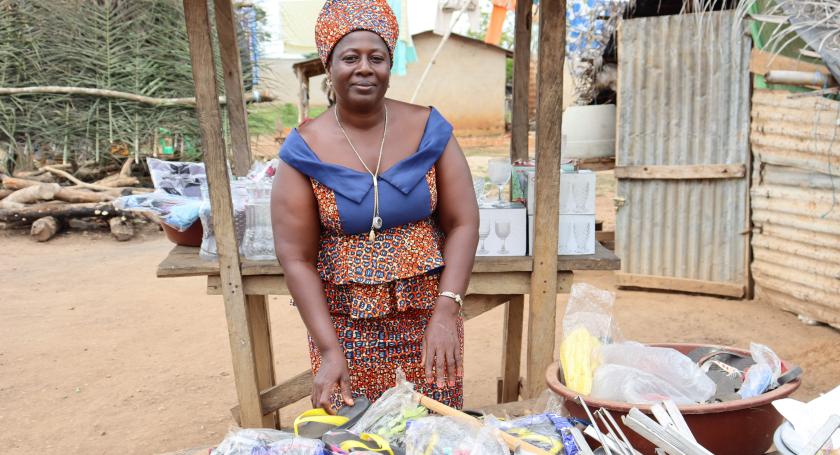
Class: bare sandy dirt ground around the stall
0,139,840,454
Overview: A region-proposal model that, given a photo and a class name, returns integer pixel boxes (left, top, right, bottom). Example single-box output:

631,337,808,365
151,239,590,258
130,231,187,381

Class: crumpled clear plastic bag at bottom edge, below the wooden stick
405,417,510,455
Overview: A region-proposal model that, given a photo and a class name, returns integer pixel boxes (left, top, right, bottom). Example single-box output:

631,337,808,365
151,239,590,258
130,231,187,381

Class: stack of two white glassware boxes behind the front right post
528,171,595,255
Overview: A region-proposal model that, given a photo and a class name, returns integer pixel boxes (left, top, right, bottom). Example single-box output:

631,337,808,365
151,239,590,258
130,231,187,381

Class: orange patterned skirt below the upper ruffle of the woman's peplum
309,275,464,409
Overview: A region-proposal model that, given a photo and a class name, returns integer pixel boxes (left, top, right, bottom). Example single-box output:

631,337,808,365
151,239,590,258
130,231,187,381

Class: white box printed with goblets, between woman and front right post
475,204,528,256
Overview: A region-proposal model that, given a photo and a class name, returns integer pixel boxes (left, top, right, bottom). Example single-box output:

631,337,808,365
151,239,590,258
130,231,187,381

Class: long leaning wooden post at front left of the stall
184,0,262,427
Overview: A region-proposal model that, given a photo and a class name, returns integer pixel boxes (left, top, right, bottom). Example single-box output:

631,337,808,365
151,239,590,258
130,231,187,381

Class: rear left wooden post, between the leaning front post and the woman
213,0,251,177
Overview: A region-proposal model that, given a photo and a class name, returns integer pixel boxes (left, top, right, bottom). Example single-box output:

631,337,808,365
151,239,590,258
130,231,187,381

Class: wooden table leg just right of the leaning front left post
246,295,280,428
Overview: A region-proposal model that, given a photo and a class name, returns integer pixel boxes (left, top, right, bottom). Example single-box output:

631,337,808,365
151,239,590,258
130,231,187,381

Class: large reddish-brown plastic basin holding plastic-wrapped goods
545,343,801,455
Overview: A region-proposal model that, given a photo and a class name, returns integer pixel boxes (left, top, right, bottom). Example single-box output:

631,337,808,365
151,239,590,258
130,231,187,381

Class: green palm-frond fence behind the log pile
0,0,259,167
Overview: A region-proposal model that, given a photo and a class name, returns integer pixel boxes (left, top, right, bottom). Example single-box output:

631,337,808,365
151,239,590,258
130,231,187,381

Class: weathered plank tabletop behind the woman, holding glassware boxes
157,242,621,278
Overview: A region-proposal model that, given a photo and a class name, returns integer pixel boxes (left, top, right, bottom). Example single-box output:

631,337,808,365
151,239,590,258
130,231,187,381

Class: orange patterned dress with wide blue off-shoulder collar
280,109,464,408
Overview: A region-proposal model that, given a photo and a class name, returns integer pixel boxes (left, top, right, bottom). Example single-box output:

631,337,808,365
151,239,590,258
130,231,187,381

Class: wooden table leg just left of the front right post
499,295,525,403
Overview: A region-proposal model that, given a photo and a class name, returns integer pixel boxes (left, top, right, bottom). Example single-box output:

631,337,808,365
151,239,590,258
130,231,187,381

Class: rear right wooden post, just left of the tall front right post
510,0,533,161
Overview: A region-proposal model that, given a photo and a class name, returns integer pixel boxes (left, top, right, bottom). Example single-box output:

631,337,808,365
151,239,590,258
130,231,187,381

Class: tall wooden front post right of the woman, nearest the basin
524,0,566,398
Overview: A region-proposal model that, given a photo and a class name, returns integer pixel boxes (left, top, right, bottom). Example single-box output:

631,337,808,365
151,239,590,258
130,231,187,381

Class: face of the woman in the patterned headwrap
327,30,391,109
